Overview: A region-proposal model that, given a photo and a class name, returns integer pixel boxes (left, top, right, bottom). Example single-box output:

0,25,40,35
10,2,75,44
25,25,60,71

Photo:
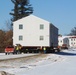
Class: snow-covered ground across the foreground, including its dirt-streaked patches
0,49,76,75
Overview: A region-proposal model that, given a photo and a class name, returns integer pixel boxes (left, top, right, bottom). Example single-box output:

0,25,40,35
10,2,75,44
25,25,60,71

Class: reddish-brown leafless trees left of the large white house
0,30,13,52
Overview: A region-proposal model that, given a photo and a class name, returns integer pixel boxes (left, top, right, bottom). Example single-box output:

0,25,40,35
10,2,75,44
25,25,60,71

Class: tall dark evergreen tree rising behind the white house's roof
10,0,33,21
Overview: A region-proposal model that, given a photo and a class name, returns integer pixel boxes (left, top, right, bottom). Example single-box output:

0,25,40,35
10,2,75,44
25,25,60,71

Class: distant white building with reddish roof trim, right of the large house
58,36,76,48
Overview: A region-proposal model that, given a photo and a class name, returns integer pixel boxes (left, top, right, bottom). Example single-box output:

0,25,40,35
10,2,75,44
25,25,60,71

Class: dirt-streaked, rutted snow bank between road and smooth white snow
0,54,65,75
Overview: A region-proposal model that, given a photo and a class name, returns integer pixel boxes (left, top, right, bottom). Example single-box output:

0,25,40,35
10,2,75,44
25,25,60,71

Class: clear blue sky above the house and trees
0,0,76,35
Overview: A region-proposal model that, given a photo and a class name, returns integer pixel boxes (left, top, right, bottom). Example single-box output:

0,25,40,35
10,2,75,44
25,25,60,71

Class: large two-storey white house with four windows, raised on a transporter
13,15,58,46
